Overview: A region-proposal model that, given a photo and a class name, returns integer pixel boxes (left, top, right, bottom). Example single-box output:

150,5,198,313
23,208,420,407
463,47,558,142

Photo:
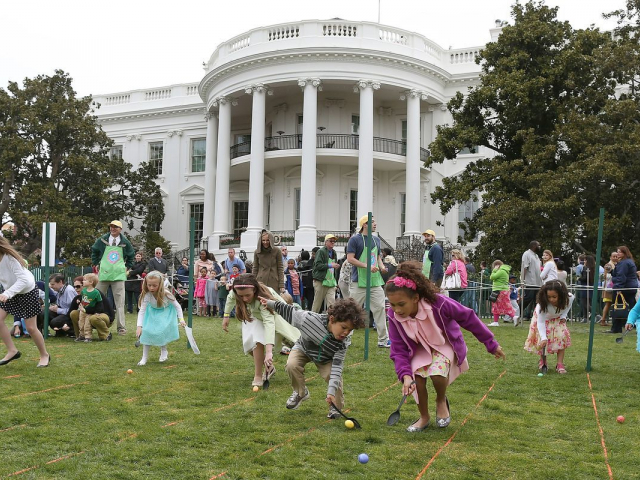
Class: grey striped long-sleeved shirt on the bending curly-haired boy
267,300,351,395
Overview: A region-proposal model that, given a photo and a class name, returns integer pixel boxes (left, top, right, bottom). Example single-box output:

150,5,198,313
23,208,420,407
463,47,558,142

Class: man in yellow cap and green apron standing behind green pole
347,215,391,348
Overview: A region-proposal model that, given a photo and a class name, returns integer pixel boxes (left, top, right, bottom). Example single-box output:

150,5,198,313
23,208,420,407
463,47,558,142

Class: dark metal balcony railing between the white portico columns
231,133,430,162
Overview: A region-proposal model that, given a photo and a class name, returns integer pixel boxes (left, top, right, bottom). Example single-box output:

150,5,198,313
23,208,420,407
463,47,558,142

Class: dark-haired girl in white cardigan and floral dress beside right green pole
524,280,574,374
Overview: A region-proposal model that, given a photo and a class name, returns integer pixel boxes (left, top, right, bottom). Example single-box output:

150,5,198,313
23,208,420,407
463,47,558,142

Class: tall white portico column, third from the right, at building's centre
296,78,322,250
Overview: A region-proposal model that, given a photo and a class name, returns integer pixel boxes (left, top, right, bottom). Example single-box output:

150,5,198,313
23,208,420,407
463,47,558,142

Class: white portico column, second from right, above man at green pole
354,80,380,218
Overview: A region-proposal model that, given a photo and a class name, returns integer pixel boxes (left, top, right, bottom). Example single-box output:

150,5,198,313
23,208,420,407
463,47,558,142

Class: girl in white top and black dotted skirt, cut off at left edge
0,237,51,367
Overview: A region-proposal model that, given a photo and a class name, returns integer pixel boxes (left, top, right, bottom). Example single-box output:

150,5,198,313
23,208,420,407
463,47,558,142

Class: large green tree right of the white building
429,1,640,267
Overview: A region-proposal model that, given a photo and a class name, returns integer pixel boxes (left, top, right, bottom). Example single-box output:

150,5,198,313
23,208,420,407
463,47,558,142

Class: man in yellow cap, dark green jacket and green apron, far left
91,220,136,335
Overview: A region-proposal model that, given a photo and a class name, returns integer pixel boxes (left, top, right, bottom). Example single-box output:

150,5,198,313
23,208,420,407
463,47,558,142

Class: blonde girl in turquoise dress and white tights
136,270,186,366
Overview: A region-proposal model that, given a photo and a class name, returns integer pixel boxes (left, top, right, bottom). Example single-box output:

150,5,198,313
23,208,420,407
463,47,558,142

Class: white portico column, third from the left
240,83,271,251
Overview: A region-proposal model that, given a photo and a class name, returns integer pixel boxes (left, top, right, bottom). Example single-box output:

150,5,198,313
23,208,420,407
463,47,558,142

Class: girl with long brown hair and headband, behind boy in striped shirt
222,273,300,387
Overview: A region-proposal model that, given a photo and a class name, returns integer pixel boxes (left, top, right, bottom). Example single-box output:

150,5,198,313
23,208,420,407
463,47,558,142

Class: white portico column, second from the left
213,97,237,249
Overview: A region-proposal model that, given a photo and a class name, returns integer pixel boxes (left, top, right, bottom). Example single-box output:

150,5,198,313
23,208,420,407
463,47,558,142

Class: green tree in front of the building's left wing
0,70,164,264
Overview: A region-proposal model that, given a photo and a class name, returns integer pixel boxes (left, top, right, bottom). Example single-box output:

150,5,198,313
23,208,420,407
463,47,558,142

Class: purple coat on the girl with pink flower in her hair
388,295,500,381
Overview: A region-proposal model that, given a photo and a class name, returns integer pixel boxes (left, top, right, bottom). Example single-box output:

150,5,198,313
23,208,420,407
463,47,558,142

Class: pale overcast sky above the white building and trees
0,0,625,95
